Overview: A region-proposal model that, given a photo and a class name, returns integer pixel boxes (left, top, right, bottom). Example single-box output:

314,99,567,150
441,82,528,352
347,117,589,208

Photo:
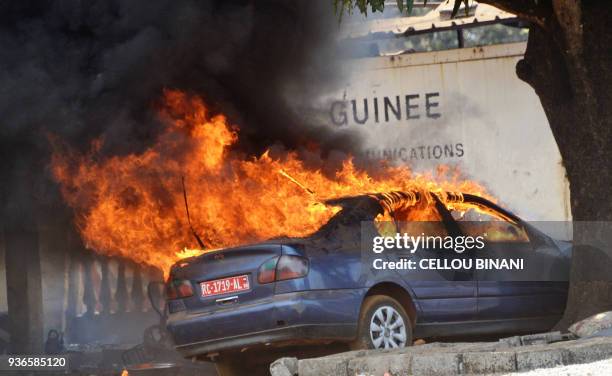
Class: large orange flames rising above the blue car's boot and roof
51,90,484,271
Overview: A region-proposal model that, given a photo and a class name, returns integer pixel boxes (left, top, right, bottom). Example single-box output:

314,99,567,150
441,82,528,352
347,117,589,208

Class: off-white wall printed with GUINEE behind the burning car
318,43,571,237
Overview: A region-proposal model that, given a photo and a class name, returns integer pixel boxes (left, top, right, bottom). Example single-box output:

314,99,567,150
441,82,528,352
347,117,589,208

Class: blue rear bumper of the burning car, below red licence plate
167,289,364,357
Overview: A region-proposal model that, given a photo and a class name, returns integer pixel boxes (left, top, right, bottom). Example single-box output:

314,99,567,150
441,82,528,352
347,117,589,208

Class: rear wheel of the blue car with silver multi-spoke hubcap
349,295,412,350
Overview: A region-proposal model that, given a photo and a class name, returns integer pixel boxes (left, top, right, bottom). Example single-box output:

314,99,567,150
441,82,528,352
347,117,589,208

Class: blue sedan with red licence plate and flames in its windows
166,191,571,374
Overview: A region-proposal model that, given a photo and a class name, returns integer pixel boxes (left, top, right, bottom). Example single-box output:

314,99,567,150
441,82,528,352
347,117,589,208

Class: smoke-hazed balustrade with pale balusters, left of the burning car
64,236,163,344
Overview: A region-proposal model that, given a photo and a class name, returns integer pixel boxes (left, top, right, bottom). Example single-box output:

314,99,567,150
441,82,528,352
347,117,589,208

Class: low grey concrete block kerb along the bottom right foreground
270,333,612,376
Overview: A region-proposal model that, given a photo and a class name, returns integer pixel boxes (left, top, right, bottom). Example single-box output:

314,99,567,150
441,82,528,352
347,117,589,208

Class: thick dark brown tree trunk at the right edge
484,0,612,329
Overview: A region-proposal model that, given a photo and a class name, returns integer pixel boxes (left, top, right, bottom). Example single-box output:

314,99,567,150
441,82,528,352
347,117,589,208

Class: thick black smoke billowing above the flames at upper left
0,0,357,219
